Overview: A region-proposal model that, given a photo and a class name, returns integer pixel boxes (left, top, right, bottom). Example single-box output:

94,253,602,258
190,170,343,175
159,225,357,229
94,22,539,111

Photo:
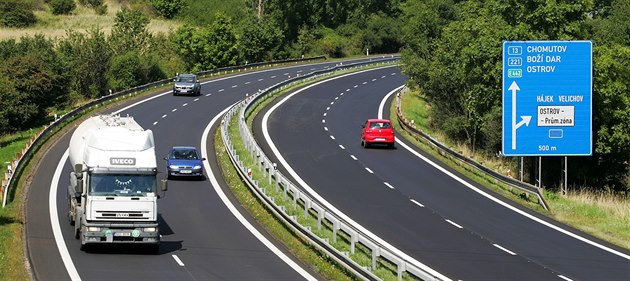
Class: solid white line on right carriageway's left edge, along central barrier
262,66,451,281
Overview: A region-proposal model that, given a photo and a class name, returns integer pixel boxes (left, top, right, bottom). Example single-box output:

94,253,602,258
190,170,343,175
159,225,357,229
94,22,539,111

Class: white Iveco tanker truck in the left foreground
68,115,167,252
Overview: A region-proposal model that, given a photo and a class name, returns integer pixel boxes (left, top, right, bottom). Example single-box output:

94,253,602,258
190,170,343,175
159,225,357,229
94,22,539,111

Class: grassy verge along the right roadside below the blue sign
400,88,630,249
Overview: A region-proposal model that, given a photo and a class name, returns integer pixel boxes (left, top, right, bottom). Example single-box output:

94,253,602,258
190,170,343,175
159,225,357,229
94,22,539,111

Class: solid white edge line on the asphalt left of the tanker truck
48,149,81,281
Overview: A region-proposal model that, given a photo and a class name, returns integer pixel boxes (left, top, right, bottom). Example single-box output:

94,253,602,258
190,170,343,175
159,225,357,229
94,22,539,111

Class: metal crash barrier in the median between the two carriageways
221,55,446,280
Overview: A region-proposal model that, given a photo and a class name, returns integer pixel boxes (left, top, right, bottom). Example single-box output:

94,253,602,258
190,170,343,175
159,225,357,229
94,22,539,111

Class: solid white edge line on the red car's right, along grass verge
378,85,630,260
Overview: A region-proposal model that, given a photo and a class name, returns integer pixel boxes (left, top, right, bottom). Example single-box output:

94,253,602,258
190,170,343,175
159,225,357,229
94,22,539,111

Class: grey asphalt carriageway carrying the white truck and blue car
25,60,380,280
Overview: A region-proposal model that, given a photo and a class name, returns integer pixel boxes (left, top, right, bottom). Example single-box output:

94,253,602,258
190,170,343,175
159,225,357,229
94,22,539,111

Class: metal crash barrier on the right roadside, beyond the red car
396,87,549,210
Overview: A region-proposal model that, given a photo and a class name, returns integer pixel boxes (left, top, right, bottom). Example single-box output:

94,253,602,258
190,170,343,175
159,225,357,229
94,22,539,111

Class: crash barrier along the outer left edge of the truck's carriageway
0,56,326,208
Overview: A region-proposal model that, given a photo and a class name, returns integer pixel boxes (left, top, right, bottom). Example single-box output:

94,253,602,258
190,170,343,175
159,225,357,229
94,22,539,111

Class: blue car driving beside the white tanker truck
164,146,206,179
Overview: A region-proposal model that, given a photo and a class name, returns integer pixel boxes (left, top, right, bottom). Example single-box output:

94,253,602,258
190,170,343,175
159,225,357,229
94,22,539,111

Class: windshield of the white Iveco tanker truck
90,174,157,196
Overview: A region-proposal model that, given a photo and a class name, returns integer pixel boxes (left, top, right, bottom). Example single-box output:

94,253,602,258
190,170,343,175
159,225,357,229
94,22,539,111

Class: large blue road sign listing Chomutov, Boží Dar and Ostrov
503,41,593,156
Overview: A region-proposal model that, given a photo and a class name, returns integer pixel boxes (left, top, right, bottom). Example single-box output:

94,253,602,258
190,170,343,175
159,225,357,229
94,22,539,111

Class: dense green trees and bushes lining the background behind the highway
0,0,630,190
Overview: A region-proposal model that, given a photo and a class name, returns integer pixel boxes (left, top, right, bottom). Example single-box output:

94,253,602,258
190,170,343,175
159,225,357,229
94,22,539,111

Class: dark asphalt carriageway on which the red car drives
254,67,630,280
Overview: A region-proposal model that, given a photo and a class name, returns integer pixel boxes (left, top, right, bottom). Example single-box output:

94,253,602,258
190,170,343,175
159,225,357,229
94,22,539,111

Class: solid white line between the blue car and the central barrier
200,104,317,281
